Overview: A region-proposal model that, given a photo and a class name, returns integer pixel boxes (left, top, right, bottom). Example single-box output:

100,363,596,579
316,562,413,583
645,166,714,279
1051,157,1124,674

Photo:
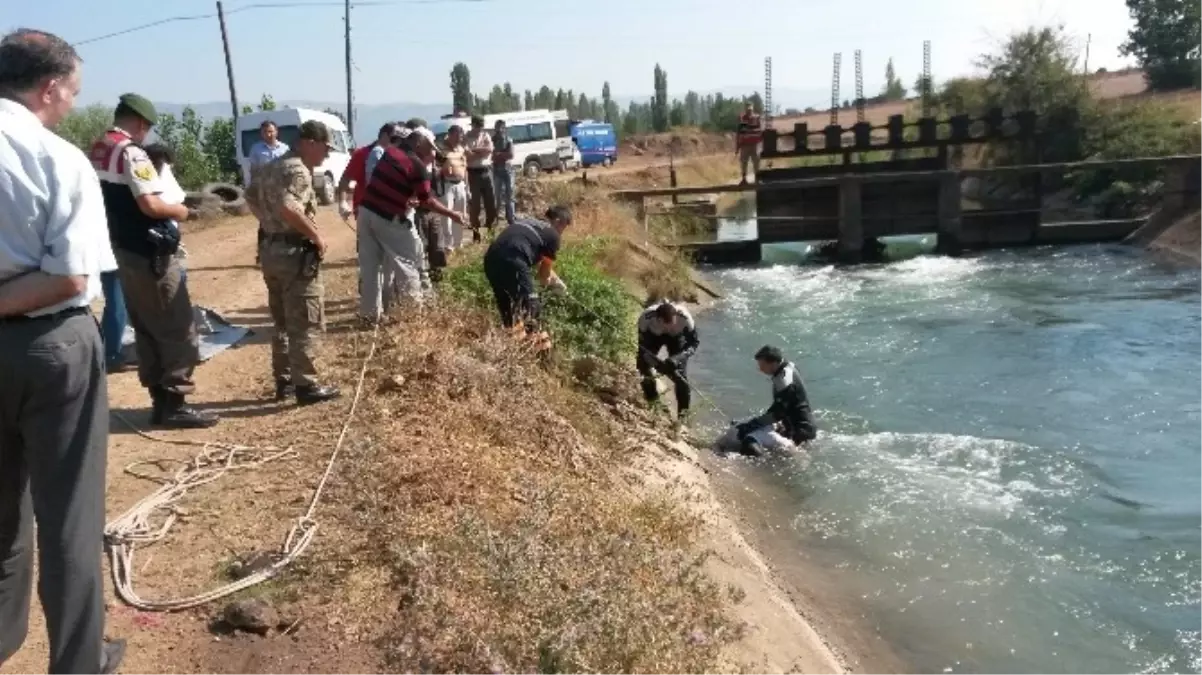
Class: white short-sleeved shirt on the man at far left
0,98,117,316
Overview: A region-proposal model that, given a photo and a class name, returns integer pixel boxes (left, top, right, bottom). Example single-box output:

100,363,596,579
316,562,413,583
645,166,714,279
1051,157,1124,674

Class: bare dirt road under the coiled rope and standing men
0,210,365,675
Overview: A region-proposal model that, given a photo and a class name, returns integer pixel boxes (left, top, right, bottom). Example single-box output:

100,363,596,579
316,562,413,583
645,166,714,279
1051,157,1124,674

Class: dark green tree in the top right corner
1120,0,1202,90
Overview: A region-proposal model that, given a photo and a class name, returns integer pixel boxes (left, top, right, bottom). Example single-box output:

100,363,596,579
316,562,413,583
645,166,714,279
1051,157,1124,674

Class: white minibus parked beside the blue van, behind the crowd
430,109,581,178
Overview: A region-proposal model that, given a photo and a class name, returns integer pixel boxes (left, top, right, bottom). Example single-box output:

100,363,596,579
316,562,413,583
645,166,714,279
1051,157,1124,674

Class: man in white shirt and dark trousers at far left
0,29,125,675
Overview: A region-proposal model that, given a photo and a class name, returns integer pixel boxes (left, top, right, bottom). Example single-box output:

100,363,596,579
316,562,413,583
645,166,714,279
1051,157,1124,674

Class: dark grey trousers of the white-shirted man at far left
0,310,108,675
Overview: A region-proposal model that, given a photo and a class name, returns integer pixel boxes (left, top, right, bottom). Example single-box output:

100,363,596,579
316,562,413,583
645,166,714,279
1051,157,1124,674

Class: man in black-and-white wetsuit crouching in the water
737,346,817,455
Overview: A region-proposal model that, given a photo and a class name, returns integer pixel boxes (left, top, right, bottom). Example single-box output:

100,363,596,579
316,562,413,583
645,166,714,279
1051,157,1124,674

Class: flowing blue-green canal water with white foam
691,228,1202,675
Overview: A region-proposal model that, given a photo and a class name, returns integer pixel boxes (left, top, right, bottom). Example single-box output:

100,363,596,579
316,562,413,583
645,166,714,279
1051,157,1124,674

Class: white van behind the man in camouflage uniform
234,108,355,204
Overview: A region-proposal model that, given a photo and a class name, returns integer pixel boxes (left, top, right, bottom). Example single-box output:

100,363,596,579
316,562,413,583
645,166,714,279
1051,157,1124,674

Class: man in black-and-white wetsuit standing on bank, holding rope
636,300,701,422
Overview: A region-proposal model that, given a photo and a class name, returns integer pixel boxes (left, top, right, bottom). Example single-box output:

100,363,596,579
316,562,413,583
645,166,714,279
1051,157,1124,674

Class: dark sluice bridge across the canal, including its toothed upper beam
613,108,1202,263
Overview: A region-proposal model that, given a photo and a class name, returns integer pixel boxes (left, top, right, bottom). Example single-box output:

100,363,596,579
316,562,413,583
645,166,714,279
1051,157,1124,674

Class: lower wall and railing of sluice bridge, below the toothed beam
612,155,1202,263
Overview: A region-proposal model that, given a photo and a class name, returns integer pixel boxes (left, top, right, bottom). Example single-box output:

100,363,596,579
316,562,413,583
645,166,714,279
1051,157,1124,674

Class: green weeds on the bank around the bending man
442,237,639,363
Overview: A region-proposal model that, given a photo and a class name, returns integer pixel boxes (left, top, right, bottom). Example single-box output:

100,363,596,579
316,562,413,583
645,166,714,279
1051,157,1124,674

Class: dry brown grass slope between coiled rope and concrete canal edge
294,307,737,674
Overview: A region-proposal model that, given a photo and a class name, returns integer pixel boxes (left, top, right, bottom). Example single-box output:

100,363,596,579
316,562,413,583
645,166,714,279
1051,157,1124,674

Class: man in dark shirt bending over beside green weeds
484,207,572,333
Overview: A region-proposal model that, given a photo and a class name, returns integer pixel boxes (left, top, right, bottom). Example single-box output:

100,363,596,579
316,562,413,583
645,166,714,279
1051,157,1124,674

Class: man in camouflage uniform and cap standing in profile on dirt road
246,121,339,405
